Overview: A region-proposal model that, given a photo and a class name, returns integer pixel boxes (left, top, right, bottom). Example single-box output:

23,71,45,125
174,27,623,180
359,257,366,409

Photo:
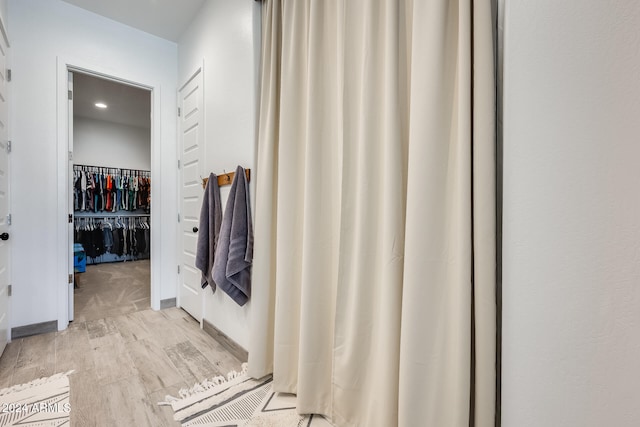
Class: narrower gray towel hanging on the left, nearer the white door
196,174,222,292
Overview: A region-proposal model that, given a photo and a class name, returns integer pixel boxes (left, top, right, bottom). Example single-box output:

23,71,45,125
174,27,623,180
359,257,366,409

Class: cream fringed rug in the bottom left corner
0,371,72,427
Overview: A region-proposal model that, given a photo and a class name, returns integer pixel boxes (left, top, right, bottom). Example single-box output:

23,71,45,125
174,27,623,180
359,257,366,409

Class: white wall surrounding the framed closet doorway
8,0,177,327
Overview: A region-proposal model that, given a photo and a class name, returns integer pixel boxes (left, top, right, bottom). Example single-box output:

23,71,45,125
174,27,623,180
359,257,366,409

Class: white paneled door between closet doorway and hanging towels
178,69,204,321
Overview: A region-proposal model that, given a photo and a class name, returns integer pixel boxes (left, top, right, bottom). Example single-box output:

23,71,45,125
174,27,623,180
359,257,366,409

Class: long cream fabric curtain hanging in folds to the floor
249,0,496,427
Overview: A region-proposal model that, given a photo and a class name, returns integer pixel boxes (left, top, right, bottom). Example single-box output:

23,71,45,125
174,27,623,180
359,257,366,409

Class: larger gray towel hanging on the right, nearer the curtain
212,166,253,305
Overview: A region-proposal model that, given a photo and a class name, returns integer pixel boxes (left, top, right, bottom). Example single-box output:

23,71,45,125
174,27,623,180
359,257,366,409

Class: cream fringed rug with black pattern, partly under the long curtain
159,365,331,427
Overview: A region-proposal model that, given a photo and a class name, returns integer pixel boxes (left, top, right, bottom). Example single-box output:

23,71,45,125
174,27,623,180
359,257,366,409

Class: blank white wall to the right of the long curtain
502,0,640,427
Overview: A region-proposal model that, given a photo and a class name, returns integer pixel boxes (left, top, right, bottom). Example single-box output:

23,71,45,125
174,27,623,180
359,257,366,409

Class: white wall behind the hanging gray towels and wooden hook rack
178,0,260,348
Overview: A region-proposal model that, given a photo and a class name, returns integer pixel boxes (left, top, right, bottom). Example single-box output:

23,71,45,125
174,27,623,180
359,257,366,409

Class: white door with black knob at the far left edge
0,22,11,354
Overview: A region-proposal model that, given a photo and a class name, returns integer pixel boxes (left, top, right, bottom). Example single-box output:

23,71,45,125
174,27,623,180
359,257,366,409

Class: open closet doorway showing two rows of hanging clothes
69,71,152,321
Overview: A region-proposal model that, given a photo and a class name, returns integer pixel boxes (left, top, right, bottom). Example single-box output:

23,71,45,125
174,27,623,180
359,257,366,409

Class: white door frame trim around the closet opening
54,56,162,331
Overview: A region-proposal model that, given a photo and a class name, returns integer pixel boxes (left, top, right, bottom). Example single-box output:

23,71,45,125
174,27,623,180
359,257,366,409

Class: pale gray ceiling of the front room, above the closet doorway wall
63,0,206,42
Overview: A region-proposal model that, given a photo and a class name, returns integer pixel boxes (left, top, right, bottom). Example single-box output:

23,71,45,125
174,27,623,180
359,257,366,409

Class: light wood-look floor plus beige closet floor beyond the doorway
0,261,241,427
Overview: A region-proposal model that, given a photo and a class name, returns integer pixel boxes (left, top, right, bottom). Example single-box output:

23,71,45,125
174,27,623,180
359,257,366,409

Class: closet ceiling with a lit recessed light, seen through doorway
73,72,151,128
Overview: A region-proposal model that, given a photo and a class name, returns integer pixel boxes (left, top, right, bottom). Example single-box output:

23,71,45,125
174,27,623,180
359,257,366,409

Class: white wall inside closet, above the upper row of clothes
73,117,151,170
